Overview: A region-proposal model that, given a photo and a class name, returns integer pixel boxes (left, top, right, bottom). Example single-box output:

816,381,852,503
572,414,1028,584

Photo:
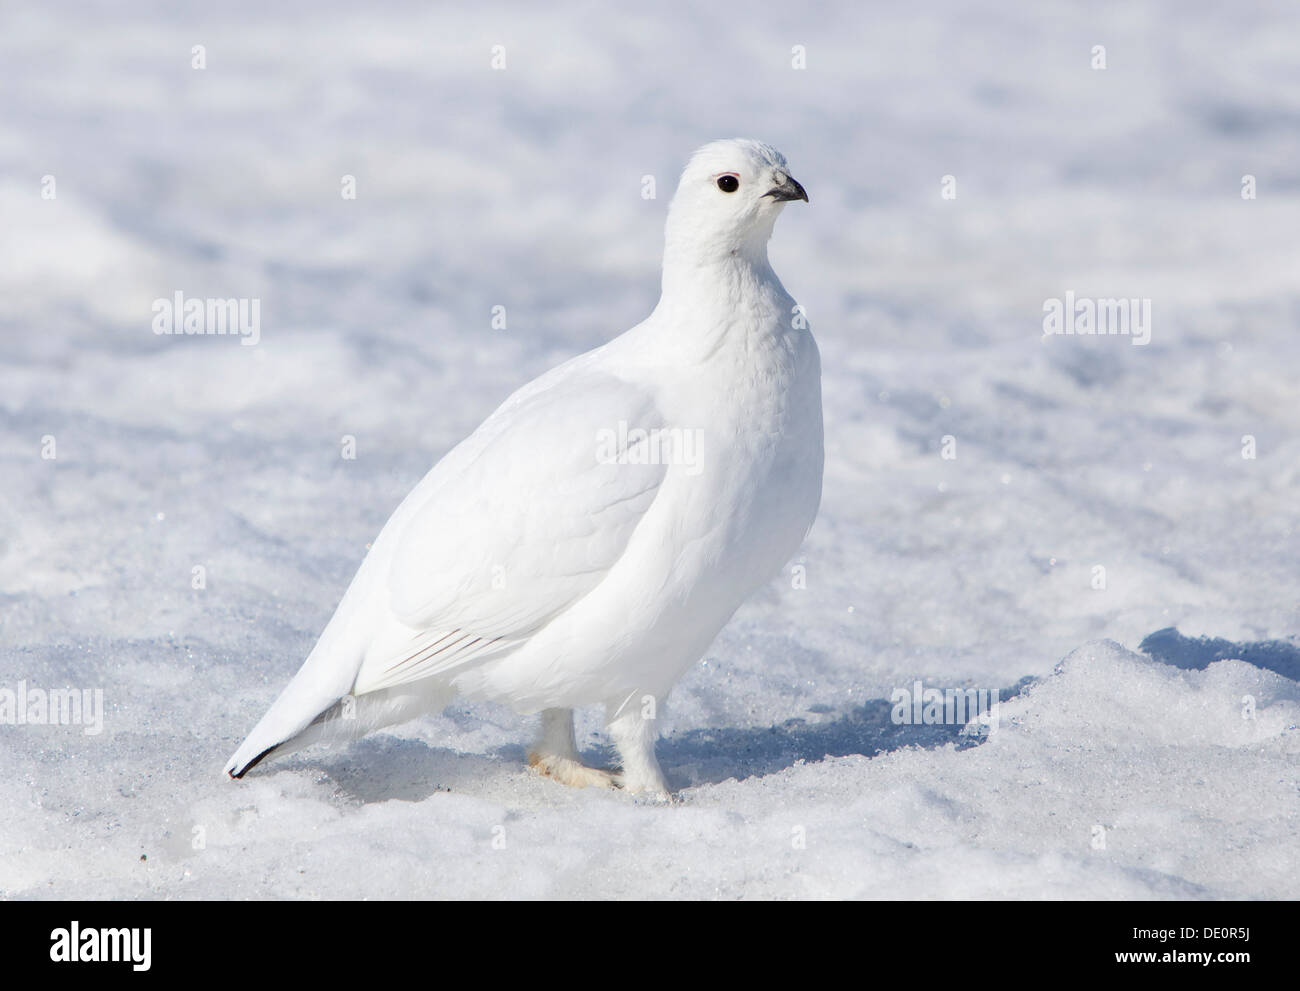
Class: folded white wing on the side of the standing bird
354,371,667,693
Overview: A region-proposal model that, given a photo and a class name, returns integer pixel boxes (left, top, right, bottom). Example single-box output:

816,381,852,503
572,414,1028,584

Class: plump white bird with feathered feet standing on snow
224,138,824,801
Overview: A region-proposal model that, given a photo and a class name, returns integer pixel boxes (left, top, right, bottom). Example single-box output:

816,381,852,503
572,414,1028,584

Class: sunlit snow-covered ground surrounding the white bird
0,0,1300,899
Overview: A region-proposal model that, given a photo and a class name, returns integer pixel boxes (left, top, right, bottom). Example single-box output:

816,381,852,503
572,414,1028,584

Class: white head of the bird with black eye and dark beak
666,138,809,263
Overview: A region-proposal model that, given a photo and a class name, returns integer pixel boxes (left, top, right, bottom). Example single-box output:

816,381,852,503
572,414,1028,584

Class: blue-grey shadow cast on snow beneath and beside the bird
308,678,1034,804
